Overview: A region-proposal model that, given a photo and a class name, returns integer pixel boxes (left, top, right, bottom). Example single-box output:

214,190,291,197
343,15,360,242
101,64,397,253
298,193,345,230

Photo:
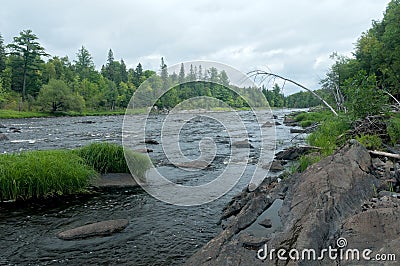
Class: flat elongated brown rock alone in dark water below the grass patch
57,219,129,240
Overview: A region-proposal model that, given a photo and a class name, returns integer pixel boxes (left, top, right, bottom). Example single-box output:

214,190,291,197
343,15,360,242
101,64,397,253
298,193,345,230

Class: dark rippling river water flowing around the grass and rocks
0,110,303,265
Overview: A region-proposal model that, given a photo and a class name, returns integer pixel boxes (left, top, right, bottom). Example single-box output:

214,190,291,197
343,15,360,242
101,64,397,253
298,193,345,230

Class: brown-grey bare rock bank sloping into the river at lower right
186,141,400,265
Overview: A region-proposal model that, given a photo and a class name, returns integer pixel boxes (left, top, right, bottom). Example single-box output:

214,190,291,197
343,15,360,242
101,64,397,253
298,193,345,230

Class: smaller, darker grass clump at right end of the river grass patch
75,142,151,178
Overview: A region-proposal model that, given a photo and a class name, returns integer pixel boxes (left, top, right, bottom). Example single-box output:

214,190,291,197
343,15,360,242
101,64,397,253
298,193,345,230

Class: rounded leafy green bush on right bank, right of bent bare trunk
345,70,388,118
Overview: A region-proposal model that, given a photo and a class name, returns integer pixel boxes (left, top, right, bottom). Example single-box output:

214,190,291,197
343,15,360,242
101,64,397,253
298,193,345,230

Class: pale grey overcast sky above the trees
0,0,390,94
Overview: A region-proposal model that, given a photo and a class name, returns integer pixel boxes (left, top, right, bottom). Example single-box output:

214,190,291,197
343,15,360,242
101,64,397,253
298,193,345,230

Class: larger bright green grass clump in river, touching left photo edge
0,150,97,201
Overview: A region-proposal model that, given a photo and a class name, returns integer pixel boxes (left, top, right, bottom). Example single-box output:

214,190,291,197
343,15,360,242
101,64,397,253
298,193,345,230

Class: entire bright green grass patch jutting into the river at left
0,143,151,201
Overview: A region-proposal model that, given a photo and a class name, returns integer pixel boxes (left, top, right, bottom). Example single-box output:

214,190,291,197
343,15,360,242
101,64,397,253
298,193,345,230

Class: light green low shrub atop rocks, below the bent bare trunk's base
307,116,350,156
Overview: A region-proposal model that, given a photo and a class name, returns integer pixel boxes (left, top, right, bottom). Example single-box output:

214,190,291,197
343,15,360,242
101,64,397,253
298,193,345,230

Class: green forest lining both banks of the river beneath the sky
0,0,400,116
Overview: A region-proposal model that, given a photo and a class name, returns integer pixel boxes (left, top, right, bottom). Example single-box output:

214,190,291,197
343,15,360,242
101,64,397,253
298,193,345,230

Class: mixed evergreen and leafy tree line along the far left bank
0,30,267,112
